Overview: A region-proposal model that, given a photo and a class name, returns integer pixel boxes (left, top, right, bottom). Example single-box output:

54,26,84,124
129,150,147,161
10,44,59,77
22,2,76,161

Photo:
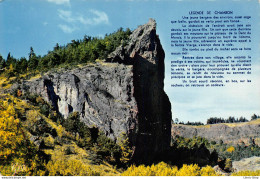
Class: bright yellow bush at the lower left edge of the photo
0,94,43,176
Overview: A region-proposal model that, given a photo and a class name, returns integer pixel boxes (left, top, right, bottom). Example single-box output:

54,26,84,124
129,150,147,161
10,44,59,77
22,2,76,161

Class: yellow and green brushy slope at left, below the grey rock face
0,95,131,176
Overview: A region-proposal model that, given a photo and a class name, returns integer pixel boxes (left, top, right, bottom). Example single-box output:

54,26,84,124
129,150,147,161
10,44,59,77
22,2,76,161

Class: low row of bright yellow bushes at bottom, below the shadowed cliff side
121,162,219,176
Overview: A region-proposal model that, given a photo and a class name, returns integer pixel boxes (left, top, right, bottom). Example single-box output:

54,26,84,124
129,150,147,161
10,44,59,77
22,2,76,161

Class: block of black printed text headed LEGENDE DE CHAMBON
170,11,252,87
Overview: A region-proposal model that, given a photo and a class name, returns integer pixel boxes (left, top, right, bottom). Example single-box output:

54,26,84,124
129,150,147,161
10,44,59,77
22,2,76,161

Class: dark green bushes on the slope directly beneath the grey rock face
59,112,123,166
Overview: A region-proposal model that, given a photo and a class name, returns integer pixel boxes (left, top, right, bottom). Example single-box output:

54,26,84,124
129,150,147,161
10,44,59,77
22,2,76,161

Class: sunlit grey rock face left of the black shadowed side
24,64,136,139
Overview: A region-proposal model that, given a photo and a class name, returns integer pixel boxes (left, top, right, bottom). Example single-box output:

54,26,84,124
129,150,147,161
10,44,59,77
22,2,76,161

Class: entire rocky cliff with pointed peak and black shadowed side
15,19,171,162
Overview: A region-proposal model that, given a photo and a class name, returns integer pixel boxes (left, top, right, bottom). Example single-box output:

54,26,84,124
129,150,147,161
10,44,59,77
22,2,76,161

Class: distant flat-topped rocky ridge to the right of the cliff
171,119,260,145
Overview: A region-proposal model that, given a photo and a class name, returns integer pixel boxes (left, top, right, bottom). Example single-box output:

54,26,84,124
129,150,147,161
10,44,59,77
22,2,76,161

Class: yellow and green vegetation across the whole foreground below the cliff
0,91,259,176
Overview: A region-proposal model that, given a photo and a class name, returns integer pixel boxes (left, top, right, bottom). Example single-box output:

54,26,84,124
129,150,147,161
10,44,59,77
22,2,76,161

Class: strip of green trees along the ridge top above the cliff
0,28,131,80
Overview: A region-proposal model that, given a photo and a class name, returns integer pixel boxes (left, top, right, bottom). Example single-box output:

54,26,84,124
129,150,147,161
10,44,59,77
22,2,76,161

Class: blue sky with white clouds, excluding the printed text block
0,0,260,123
